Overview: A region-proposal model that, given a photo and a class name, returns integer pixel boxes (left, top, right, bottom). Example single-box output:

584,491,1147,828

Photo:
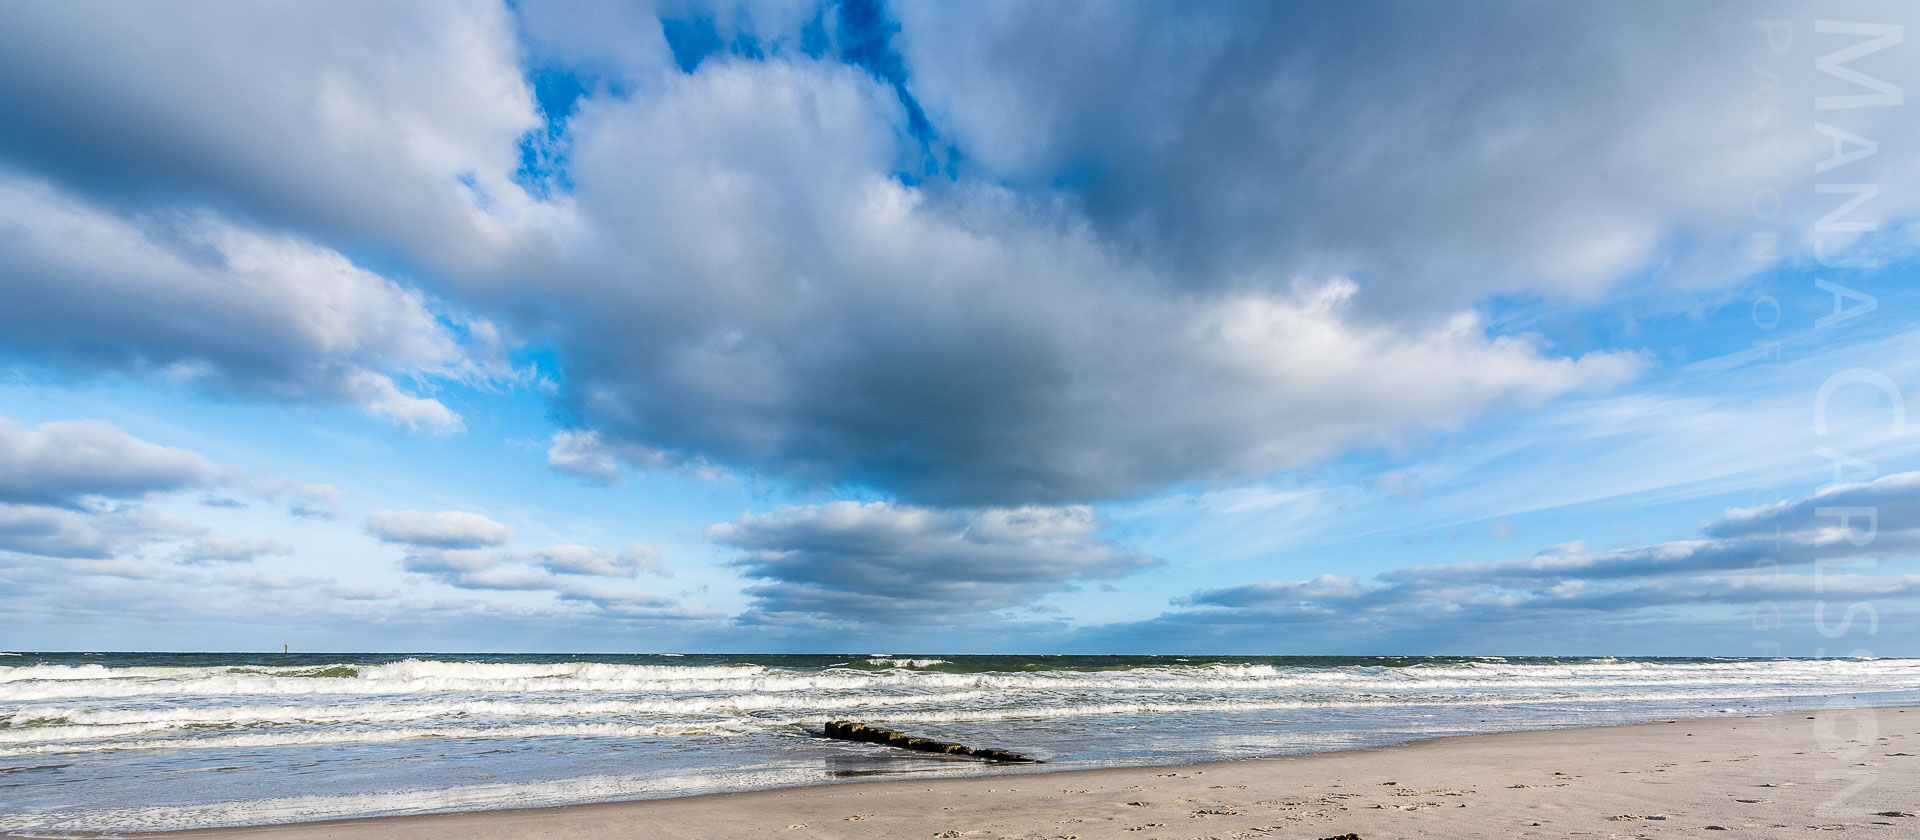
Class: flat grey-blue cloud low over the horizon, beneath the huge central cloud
707,502,1160,623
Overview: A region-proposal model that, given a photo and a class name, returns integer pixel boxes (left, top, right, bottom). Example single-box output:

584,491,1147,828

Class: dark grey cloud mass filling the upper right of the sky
895,2,1916,313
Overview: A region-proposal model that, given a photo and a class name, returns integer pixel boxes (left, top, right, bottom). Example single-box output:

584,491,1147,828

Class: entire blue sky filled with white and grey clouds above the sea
0,0,1920,656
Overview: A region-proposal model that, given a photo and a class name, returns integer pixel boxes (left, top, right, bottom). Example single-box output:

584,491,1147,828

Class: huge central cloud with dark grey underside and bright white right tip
549,61,1640,504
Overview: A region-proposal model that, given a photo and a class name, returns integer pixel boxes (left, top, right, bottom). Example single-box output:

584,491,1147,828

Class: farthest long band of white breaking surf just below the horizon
0,660,1920,704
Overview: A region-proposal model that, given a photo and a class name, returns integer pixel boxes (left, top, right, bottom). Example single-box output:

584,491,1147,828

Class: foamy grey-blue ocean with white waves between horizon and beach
0,654,1920,836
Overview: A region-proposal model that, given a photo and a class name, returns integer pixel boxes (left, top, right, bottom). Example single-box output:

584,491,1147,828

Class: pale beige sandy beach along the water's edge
149,708,1920,840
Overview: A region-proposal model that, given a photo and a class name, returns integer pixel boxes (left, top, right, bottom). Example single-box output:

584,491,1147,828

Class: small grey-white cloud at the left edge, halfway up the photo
0,418,217,506
